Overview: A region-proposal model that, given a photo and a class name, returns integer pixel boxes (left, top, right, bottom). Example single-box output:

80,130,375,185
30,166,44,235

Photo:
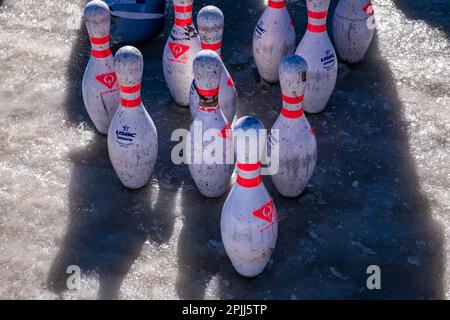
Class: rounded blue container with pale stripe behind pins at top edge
103,0,166,43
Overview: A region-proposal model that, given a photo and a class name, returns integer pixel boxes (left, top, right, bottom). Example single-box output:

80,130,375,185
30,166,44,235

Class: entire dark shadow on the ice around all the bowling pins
48,0,444,299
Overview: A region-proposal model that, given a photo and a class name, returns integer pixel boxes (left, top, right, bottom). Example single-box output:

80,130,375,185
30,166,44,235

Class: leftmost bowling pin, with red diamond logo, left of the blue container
82,0,119,134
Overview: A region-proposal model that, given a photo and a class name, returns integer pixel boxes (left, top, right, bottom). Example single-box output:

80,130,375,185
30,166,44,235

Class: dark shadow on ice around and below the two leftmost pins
48,2,181,299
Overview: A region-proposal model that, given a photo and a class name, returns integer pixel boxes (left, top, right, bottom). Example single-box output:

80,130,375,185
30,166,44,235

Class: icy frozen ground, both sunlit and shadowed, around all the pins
0,0,450,299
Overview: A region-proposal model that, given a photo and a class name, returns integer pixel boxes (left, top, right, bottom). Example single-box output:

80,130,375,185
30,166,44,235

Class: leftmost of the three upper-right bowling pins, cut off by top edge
253,0,295,83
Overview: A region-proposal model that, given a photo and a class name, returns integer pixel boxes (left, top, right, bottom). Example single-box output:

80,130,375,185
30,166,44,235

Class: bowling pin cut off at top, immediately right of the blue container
163,0,201,107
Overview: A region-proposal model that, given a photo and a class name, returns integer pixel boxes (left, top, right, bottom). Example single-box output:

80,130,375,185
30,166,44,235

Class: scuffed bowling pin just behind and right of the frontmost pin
269,55,317,197
